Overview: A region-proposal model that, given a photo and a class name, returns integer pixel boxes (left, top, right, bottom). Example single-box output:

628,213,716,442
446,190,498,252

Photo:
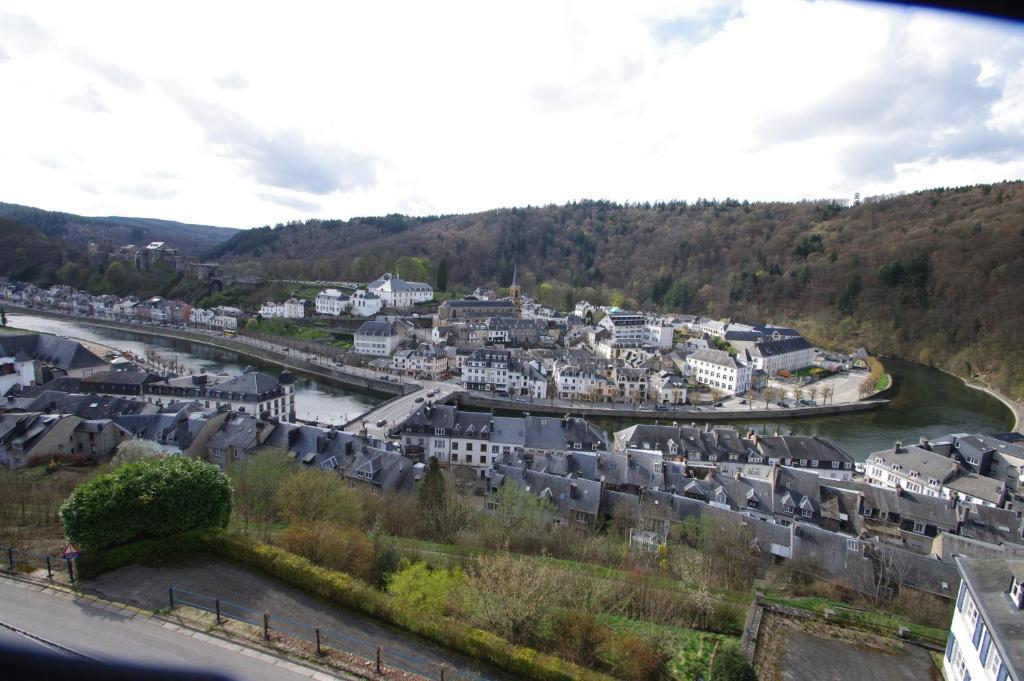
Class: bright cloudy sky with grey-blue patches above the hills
0,0,1024,226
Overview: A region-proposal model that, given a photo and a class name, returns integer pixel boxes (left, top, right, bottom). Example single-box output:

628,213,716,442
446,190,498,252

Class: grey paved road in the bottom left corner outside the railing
0,578,332,681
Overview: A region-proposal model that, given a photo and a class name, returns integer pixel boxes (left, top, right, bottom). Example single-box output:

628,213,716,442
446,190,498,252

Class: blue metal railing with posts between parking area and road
167,586,488,681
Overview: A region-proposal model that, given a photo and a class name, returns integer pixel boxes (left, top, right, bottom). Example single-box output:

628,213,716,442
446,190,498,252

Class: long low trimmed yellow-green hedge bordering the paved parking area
79,529,610,681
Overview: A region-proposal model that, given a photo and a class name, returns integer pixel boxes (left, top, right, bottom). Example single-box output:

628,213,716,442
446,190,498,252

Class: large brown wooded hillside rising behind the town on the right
212,182,1024,397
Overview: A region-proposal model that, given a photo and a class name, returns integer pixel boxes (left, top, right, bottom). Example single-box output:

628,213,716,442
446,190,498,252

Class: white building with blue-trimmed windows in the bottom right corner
942,556,1024,681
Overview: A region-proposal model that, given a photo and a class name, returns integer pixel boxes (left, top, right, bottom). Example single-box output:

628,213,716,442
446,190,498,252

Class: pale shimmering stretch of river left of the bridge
7,312,383,425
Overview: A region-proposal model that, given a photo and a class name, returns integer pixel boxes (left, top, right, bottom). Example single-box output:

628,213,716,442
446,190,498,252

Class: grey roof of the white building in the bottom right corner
953,556,1024,679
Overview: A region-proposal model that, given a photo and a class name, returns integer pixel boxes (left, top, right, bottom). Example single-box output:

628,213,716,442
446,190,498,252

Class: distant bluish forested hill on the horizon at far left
0,203,238,255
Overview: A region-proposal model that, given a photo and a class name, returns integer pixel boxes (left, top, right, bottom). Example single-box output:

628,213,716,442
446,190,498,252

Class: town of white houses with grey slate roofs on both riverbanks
0,274,1024,614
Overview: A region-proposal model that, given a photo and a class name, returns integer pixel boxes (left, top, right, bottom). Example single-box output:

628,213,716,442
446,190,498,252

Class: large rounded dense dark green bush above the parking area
60,457,231,551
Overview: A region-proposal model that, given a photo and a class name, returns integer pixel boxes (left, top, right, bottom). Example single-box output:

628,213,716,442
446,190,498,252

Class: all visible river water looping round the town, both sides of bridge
7,312,1013,461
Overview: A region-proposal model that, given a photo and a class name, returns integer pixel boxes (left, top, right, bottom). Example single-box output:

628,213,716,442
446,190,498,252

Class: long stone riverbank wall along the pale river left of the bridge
7,305,411,397
